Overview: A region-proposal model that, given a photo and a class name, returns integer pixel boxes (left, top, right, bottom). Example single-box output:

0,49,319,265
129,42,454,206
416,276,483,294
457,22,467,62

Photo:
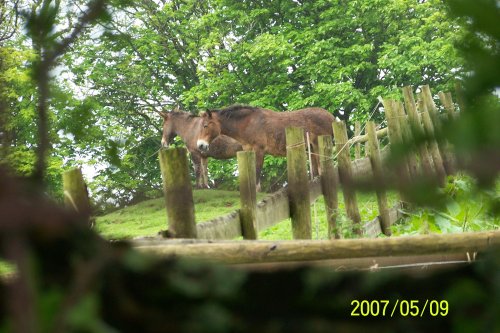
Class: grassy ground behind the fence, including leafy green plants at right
96,176,500,240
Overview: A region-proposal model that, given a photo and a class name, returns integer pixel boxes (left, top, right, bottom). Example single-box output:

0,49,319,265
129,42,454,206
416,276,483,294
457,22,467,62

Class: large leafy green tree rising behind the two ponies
56,0,462,200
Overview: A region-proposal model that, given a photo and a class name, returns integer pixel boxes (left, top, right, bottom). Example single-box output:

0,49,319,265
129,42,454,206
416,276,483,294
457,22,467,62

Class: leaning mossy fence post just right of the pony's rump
332,121,363,236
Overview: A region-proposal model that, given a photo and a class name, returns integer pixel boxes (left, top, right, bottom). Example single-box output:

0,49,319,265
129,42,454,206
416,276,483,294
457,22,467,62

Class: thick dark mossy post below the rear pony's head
159,147,196,238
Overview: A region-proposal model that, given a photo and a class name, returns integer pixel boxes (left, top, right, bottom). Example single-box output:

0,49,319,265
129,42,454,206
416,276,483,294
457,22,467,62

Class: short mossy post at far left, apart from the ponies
63,168,91,225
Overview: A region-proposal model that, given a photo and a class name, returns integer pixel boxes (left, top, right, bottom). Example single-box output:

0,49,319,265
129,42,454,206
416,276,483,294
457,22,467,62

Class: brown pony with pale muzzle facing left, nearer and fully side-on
197,105,335,186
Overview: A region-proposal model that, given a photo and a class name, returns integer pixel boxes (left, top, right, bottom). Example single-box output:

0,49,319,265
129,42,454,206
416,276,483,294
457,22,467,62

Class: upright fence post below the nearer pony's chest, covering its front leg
236,151,258,239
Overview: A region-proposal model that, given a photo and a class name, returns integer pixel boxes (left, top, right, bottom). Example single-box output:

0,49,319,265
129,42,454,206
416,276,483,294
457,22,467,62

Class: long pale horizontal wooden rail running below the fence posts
137,231,500,264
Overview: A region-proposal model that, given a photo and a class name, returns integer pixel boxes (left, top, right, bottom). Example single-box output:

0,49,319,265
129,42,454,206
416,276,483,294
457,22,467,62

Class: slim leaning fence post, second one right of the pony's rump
366,121,391,236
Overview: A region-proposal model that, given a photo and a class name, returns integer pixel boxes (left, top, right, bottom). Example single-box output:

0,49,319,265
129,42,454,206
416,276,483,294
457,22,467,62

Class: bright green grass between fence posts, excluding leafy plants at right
96,190,397,240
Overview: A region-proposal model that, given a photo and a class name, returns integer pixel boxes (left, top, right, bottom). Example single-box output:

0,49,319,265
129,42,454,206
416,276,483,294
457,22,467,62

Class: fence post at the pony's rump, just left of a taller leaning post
318,135,340,239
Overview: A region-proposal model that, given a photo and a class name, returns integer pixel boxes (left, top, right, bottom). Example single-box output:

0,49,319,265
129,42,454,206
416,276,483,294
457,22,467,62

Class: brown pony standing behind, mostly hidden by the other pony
160,111,243,188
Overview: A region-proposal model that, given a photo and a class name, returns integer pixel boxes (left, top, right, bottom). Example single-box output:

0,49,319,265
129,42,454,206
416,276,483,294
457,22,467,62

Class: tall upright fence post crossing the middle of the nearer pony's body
286,127,312,239
